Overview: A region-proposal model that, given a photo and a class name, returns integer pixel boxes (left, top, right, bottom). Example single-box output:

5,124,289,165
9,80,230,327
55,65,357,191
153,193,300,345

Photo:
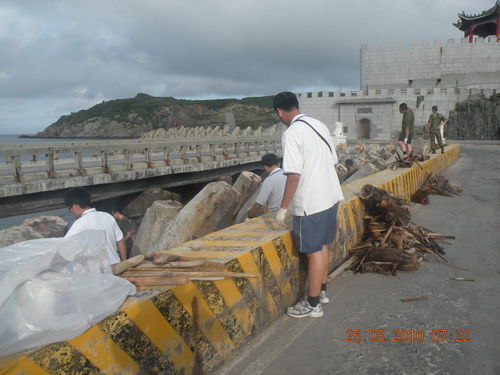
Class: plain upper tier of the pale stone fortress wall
360,36,500,89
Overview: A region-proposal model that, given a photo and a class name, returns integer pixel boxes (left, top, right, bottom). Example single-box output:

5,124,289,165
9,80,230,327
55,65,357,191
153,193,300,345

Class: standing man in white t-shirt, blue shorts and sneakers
274,92,344,318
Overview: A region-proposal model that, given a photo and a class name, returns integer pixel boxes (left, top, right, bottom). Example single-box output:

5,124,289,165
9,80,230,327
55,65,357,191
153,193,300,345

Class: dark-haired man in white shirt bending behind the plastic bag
64,188,127,264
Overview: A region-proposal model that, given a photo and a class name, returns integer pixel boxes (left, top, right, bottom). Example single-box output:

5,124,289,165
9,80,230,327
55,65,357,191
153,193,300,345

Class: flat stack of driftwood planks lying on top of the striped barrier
112,253,257,289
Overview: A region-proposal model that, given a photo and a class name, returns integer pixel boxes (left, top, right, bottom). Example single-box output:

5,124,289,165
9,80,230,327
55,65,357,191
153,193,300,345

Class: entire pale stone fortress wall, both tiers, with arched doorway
297,37,500,141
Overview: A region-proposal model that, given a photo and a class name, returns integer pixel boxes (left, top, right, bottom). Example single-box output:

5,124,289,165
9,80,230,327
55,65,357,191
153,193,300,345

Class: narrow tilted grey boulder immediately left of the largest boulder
132,200,182,256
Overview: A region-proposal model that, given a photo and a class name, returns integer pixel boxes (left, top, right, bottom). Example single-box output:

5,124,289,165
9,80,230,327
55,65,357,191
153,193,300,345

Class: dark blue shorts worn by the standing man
292,202,339,253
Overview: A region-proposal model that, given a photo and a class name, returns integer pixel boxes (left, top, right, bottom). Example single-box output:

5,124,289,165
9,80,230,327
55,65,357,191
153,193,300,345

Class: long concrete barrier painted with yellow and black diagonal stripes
0,145,460,374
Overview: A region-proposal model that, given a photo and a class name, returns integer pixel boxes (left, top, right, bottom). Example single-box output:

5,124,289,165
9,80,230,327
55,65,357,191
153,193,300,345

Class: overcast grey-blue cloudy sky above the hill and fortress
0,0,494,134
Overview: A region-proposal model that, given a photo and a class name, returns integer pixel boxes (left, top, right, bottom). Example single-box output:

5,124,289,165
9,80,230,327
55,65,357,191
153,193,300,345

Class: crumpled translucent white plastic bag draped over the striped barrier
0,231,135,356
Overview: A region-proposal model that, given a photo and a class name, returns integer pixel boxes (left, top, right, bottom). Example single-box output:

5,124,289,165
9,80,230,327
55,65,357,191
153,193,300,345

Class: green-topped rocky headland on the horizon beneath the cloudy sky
36,94,279,138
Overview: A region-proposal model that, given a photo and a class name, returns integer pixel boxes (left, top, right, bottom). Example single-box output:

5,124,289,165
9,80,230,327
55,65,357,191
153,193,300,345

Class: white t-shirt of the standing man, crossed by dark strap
281,114,344,216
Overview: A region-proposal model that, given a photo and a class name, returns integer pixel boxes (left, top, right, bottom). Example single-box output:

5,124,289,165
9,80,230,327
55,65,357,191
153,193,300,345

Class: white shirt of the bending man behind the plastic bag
64,208,123,264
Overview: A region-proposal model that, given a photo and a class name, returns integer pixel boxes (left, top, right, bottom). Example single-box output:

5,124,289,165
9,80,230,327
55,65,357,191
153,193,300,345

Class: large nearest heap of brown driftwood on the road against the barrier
349,185,458,275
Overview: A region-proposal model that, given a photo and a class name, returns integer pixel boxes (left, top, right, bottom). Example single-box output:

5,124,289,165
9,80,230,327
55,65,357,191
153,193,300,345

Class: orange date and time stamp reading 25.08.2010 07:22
345,329,471,343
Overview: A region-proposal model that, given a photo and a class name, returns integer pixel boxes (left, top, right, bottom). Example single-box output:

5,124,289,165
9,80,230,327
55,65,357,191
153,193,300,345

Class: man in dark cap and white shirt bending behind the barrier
247,154,286,217
